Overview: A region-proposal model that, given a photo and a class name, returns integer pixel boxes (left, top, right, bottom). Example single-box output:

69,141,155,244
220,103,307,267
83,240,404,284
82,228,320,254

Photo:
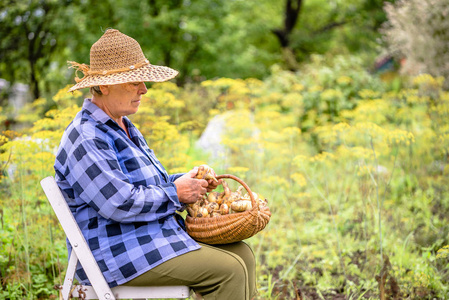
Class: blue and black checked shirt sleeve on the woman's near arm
66,138,181,223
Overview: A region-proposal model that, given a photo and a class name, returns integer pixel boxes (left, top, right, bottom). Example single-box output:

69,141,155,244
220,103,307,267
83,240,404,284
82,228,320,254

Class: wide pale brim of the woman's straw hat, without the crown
69,64,179,92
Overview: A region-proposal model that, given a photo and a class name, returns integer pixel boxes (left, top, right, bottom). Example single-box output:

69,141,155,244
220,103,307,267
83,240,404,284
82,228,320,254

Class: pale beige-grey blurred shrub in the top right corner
383,0,449,87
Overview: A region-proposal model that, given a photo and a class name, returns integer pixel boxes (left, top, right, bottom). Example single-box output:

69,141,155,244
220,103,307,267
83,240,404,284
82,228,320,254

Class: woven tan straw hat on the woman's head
68,29,178,92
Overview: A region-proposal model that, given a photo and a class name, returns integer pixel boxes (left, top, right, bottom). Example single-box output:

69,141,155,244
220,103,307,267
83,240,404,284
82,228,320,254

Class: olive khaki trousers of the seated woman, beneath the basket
124,242,256,300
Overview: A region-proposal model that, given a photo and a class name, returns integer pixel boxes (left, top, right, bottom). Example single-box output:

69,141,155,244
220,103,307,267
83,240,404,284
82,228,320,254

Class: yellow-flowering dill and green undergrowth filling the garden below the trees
0,56,449,299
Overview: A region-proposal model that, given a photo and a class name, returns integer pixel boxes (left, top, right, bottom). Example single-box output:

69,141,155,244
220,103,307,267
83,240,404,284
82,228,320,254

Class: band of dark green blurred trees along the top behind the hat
0,0,392,104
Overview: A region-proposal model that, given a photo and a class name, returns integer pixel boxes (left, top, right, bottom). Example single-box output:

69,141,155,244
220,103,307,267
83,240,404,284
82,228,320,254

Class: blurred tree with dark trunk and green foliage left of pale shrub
272,0,392,70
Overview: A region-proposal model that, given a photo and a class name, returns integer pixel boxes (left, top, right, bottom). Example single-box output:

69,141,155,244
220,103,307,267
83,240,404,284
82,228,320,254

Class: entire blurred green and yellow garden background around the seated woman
0,0,449,299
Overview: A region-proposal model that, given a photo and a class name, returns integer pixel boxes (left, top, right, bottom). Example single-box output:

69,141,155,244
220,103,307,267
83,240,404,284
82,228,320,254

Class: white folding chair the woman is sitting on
41,176,190,300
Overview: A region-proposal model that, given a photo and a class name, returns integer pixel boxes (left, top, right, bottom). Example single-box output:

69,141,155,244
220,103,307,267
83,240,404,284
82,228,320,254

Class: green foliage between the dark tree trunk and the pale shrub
292,0,394,61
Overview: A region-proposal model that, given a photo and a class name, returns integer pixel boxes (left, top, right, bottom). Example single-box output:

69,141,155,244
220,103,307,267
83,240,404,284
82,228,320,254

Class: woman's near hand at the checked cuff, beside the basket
174,167,210,204
